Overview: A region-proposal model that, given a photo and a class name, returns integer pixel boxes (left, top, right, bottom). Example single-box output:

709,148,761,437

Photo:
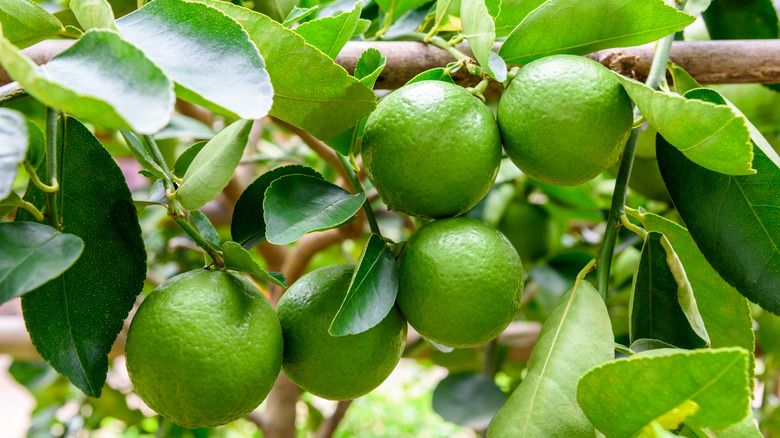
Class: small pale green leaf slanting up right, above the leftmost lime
175,118,252,211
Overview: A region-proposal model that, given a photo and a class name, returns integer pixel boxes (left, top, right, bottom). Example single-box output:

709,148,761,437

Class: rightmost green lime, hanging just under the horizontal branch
498,55,633,186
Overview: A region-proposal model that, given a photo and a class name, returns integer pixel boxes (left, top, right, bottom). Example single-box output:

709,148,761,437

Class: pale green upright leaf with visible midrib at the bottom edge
488,281,615,438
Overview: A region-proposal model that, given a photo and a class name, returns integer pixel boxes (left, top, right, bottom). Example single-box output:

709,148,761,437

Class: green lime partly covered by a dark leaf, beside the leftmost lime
276,265,406,400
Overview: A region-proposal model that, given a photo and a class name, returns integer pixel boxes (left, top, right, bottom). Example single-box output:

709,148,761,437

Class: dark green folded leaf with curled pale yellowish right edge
629,231,709,349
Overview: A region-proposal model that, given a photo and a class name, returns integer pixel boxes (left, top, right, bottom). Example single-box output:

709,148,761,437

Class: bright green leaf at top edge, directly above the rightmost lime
498,0,696,64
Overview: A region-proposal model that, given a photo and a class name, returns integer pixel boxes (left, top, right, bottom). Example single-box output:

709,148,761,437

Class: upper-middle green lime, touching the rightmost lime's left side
362,81,501,218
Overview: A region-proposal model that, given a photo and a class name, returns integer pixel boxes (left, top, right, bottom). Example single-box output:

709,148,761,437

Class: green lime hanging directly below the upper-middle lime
397,218,524,348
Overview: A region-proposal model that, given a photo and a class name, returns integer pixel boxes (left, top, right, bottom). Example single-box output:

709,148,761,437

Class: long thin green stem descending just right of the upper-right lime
596,27,674,301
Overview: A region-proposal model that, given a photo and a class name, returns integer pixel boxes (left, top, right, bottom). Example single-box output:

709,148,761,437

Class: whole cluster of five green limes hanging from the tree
126,55,632,427
